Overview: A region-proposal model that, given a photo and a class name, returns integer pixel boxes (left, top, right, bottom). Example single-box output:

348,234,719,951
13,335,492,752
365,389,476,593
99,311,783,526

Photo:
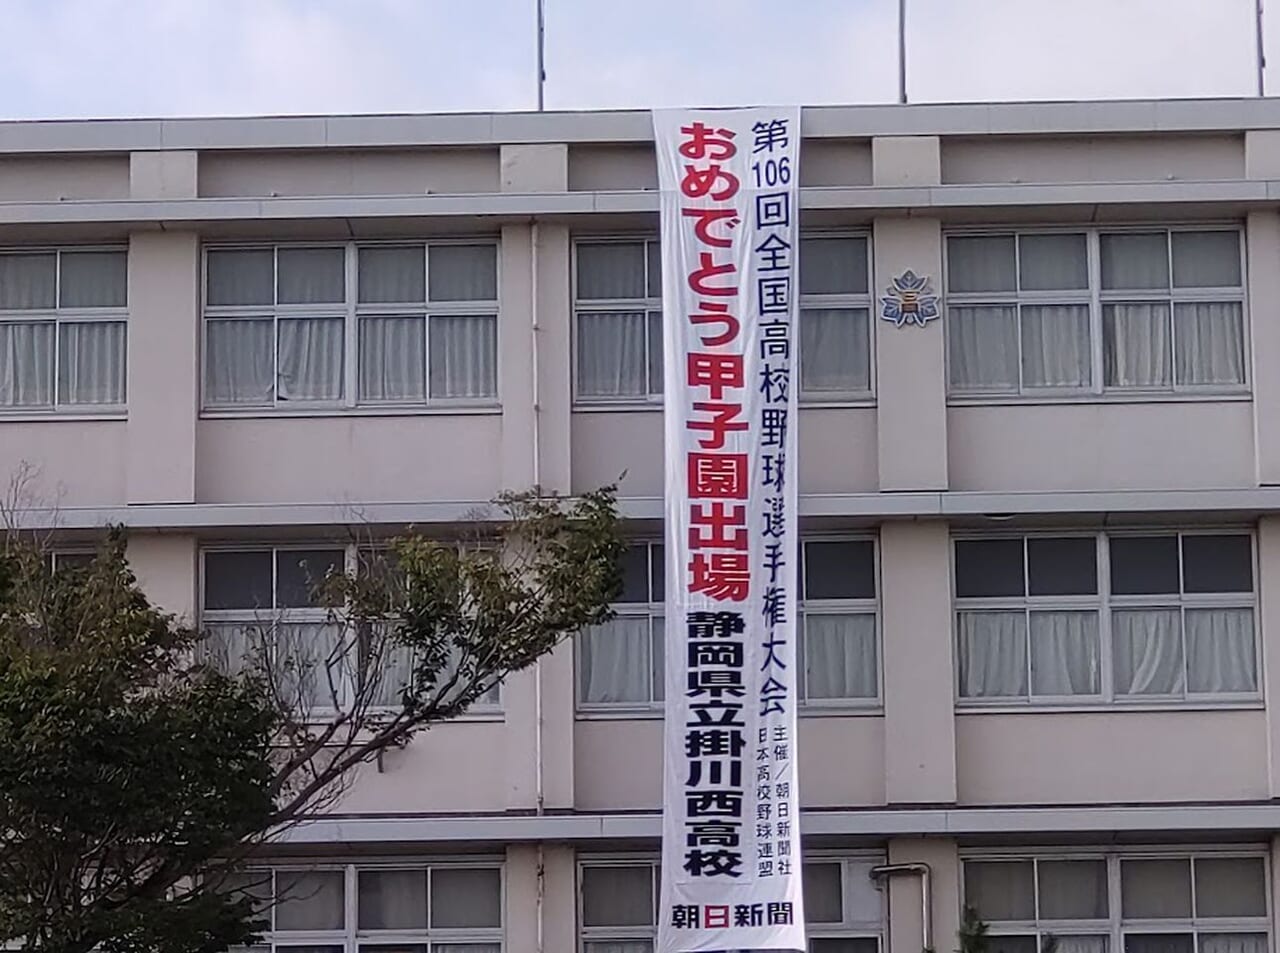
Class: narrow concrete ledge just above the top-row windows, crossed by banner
0,179,1280,229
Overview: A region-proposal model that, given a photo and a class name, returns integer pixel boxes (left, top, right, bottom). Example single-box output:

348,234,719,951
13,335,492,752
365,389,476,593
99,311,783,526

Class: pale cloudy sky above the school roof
0,0,1280,119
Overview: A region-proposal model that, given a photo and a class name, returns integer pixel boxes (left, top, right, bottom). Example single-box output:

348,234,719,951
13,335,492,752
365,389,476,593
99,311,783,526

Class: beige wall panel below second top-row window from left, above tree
196,413,502,506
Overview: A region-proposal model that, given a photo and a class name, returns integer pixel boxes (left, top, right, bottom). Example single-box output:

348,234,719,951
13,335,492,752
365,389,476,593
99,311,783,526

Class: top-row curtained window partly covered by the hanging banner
575,234,872,403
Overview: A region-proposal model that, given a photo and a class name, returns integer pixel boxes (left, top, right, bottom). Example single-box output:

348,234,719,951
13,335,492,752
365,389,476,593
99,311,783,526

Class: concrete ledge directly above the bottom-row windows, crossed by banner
278,803,1280,846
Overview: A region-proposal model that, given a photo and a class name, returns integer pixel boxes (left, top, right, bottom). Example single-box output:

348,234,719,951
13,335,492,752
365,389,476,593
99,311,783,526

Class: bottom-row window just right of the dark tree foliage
227,865,503,953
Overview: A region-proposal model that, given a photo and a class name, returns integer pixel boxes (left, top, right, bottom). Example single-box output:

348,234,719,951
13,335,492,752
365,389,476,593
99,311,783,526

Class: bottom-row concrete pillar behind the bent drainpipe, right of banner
888,838,960,953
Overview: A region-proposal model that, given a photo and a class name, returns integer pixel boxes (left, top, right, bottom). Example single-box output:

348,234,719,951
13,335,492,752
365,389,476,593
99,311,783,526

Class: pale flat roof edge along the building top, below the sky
0,98,1280,155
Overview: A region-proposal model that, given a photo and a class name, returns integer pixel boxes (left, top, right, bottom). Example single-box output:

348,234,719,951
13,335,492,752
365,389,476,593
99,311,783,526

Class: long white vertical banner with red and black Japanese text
654,107,806,953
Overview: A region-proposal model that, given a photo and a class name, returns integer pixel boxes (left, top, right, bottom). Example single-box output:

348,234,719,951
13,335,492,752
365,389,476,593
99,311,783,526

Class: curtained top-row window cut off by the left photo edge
0,248,128,411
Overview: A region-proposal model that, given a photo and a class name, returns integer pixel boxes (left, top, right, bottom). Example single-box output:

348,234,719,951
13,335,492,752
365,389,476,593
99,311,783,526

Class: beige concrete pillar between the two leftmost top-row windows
127,232,200,503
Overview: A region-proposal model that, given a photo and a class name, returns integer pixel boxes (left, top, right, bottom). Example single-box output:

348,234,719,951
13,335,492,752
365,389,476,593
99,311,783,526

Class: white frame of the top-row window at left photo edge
0,242,129,420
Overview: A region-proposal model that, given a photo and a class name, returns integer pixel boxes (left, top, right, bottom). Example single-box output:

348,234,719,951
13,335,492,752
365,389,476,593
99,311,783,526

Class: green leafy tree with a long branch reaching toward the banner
0,487,623,953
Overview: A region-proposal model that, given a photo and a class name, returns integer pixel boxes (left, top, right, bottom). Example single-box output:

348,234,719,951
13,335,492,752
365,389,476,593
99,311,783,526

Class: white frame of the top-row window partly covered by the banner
570,234,877,411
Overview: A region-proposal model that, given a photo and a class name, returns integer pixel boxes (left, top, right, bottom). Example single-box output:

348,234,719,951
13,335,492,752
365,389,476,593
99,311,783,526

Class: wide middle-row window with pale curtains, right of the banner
955,532,1258,704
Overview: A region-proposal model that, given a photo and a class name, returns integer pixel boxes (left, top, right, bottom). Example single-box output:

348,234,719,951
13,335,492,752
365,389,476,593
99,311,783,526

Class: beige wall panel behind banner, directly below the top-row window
571,407,878,496
